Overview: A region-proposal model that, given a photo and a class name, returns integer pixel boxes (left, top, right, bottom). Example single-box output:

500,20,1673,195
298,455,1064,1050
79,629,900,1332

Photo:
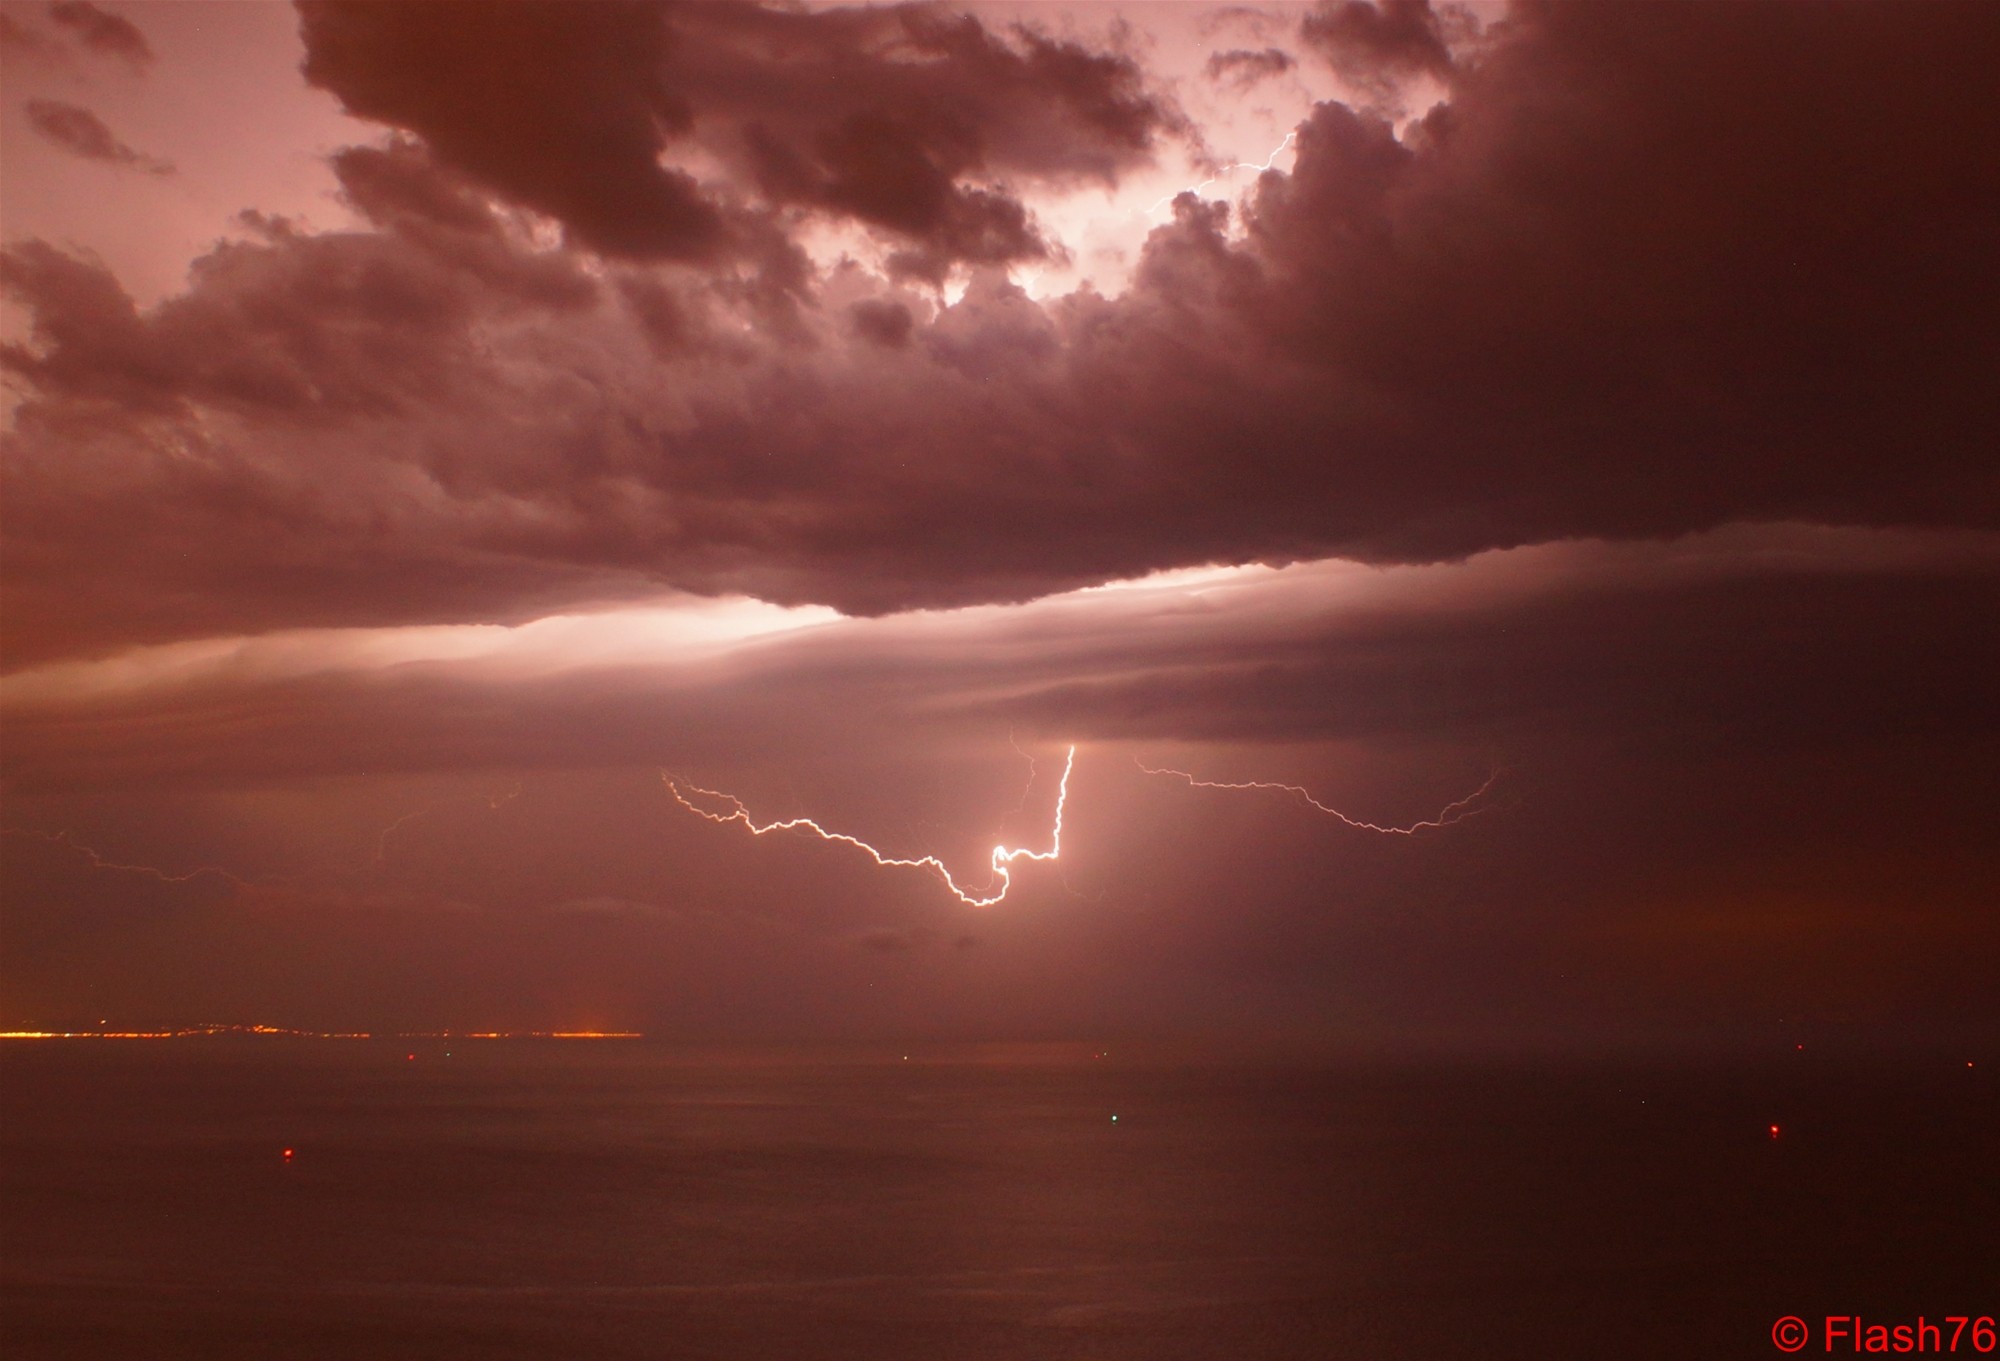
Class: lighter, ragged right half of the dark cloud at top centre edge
676,6,1180,280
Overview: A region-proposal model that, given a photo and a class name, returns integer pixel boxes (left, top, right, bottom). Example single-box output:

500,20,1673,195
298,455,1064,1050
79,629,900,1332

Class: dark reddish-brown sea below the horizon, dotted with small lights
0,1041,2000,1361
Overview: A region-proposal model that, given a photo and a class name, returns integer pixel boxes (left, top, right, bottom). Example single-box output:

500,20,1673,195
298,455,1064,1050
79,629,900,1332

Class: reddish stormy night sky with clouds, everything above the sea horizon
0,0,2000,1051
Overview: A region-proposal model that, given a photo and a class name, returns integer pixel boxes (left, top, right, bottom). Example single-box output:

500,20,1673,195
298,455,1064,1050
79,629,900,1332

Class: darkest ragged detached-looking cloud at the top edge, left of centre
300,2,1174,278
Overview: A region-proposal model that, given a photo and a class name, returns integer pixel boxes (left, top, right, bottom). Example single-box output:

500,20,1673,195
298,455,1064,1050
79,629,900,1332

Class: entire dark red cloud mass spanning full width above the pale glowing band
4,4,2000,654
